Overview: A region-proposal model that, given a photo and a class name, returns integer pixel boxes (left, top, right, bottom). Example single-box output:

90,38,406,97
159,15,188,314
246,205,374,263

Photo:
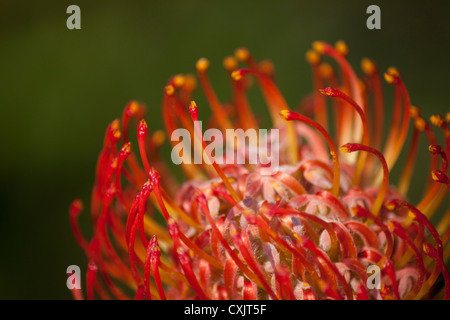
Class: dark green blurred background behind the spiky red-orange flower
0,0,450,299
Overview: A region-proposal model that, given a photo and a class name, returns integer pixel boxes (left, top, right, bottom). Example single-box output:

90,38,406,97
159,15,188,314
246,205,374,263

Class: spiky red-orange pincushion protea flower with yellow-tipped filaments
70,42,450,300
